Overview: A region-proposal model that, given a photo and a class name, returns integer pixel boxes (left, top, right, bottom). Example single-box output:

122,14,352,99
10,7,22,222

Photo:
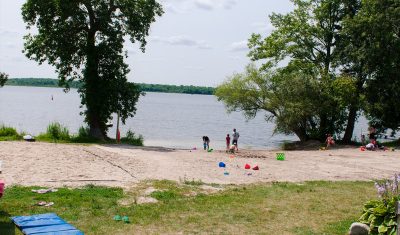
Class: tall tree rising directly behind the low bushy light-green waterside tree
245,0,348,140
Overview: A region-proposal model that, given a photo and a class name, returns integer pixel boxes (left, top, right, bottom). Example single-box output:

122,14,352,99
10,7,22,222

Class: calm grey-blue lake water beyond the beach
0,86,367,149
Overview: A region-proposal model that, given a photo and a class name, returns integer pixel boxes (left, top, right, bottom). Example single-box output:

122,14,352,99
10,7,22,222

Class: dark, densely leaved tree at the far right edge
344,0,400,131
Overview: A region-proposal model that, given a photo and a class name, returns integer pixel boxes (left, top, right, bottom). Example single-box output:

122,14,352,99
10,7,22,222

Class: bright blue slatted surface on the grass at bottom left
11,213,83,235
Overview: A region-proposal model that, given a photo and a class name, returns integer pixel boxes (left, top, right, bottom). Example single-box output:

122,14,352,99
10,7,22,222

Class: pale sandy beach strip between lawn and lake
0,142,400,187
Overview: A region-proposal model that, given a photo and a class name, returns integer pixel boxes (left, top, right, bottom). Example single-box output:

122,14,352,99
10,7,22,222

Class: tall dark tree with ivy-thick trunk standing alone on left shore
22,0,163,139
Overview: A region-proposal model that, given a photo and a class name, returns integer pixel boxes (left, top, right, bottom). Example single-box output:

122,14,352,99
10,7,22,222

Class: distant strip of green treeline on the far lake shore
5,78,214,95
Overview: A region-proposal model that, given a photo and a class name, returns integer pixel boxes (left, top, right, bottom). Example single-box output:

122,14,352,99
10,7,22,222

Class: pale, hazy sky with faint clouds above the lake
0,0,293,87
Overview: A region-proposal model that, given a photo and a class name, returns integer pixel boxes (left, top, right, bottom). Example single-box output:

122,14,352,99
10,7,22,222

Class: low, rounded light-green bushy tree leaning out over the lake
215,64,319,141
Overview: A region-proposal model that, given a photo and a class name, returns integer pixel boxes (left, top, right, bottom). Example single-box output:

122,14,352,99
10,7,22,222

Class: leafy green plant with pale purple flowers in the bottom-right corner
359,174,400,235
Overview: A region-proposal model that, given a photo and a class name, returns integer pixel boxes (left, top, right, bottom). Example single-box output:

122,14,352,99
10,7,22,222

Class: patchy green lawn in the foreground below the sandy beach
0,180,376,234
